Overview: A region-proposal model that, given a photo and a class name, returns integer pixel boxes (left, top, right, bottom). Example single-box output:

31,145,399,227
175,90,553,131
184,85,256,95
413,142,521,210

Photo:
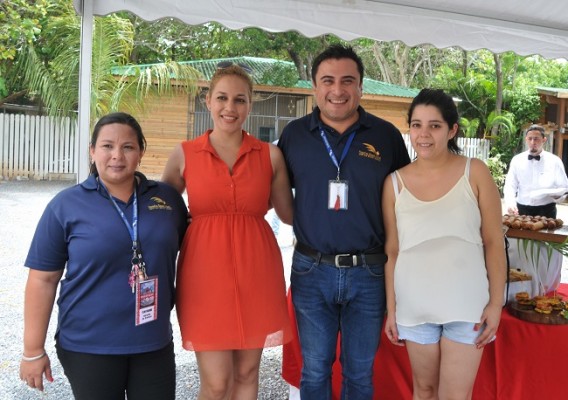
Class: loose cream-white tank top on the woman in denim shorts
391,158,489,326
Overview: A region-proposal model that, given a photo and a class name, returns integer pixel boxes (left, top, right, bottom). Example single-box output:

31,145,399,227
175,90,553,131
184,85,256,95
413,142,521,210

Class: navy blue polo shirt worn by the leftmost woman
25,174,187,354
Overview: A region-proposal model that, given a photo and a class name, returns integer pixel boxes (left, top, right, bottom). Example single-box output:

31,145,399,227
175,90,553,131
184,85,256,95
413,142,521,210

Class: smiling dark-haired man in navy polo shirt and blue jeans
278,45,410,400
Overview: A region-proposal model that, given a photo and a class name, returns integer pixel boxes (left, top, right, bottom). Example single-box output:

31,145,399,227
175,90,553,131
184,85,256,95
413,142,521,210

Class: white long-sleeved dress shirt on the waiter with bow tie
503,150,568,208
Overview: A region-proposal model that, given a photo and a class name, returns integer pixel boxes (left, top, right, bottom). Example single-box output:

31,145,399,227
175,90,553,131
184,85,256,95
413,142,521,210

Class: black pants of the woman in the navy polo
56,343,176,400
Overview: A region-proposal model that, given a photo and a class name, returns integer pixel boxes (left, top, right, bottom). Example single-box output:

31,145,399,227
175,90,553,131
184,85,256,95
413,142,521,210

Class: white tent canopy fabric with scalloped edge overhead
74,0,568,58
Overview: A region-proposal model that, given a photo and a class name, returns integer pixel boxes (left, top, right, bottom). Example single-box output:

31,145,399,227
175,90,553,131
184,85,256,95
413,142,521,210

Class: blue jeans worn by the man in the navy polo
291,251,385,400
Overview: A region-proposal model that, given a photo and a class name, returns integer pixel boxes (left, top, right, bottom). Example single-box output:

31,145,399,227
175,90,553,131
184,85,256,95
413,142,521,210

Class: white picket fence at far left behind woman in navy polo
0,113,77,180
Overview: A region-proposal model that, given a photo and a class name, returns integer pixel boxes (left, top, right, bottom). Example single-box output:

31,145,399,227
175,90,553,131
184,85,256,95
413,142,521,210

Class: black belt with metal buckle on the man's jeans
296,242,387,268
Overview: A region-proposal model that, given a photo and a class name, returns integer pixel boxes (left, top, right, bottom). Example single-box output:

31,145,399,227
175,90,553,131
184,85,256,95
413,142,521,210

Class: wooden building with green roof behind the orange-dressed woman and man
126,57,418,178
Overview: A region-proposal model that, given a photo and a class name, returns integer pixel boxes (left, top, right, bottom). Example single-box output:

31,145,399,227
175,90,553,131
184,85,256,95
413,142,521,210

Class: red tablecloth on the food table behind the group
282,284,568,400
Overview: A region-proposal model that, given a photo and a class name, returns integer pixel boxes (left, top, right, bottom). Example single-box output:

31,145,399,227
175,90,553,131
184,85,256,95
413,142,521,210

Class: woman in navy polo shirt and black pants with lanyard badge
20,113,187,400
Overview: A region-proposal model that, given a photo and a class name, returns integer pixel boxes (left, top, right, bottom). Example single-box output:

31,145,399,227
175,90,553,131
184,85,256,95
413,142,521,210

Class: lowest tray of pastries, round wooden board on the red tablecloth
509,292,568,325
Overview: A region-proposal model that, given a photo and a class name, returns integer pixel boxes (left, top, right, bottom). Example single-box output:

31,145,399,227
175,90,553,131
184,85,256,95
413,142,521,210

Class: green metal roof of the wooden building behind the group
112,57,420,98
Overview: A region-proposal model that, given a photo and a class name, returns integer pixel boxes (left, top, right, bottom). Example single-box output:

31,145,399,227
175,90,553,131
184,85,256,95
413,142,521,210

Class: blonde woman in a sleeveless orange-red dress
162,65,292,399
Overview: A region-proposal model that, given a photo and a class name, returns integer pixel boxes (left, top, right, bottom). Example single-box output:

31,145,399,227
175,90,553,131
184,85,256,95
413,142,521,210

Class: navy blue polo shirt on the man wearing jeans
278,107,410,254
